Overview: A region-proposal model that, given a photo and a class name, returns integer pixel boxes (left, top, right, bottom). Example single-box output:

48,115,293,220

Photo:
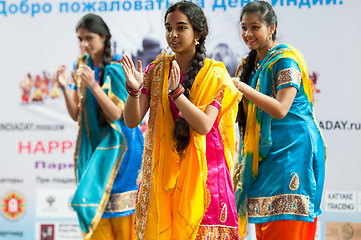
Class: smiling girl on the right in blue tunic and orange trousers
234,1,326,240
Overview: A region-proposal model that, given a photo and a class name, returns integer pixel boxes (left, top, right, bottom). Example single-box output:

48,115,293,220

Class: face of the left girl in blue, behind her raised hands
77,28,105,59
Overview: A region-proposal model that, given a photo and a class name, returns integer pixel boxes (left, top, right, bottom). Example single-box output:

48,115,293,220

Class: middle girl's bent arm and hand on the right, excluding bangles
168,61,218,135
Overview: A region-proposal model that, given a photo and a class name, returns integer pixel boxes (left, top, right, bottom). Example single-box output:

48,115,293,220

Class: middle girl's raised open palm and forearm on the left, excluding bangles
122,55,149,128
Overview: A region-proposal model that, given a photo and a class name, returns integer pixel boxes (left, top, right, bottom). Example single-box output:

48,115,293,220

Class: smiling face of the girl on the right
241,13,275,55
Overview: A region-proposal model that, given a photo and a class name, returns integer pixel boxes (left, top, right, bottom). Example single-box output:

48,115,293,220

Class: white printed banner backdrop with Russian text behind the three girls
0,0,361,240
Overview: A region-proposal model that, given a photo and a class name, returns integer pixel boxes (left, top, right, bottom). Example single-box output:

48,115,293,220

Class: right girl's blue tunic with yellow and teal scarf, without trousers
235,44,326,235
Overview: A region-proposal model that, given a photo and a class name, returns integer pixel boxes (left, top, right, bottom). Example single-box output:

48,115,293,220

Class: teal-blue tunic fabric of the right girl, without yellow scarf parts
235,44,325,223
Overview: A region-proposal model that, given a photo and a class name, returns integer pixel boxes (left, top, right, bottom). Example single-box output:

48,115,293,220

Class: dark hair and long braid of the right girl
237,1,277,134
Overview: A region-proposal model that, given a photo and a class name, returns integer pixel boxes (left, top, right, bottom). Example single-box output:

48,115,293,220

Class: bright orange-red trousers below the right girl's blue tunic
255,218,317,240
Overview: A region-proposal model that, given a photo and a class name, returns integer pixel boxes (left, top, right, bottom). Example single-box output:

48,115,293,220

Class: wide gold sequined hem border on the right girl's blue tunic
248,194,310,217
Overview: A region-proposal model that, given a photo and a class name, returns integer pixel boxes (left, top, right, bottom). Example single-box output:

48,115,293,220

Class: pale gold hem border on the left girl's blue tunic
104,190,137,212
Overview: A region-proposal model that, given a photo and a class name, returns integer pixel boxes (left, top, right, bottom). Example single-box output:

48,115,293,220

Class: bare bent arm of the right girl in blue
236,81,297,119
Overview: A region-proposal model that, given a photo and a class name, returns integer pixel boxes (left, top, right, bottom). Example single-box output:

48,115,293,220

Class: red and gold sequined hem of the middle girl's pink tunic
195,225,238,240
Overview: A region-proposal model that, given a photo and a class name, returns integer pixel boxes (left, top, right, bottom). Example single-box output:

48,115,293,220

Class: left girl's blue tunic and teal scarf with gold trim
71,54,143,238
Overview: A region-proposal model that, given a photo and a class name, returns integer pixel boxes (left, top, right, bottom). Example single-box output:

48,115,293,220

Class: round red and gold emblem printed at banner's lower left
1,192,25,220
